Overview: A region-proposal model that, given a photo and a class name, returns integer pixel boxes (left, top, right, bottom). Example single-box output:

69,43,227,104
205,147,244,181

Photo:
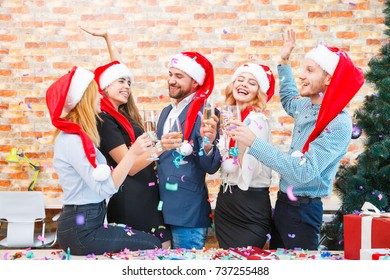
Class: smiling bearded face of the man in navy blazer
168,67,199,103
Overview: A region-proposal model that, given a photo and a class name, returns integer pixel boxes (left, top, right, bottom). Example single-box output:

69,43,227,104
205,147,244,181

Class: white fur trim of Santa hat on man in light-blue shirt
305,45,340,76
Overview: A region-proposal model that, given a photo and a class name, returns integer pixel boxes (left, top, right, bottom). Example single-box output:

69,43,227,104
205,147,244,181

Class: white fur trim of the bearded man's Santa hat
168,53,206,85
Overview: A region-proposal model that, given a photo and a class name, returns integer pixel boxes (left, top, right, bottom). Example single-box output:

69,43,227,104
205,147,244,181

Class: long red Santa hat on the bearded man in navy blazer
168,52,214,140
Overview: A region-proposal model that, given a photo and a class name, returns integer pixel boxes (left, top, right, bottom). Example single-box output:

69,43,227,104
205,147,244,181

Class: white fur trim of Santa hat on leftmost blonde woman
64,67,94,113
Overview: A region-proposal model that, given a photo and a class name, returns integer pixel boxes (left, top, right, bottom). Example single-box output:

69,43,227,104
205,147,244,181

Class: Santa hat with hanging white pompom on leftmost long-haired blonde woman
46,66,111,181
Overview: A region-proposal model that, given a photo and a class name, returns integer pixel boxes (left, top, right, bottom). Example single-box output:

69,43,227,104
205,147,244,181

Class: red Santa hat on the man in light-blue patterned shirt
302,45,364,153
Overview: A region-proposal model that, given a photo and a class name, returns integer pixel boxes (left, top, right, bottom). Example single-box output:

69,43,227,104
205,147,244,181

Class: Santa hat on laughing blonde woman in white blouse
231,62,275,102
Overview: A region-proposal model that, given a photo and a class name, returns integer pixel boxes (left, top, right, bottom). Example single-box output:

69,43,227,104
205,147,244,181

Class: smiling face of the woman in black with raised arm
104,77,131,109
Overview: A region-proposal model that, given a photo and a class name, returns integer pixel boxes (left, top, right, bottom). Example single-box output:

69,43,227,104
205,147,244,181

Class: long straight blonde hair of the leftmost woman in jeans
54,80,100,147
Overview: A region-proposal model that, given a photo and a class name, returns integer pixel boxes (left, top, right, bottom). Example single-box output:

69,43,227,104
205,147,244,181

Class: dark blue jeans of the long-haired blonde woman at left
57,201,161,255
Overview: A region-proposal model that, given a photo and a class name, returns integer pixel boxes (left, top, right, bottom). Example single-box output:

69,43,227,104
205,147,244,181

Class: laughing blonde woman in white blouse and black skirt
214,63,275,249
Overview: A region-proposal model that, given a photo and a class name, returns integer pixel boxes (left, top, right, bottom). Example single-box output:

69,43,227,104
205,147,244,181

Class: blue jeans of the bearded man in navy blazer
171,225,208,250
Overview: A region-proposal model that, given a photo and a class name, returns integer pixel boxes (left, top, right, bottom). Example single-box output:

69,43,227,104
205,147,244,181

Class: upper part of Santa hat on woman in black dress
95,61,134,89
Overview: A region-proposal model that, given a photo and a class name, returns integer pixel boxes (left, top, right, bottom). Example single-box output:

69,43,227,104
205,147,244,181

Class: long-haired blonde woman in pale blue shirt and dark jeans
46,66,161,255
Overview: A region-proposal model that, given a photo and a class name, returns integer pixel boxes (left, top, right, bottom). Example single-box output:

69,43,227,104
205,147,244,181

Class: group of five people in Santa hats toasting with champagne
46,28,364,255
